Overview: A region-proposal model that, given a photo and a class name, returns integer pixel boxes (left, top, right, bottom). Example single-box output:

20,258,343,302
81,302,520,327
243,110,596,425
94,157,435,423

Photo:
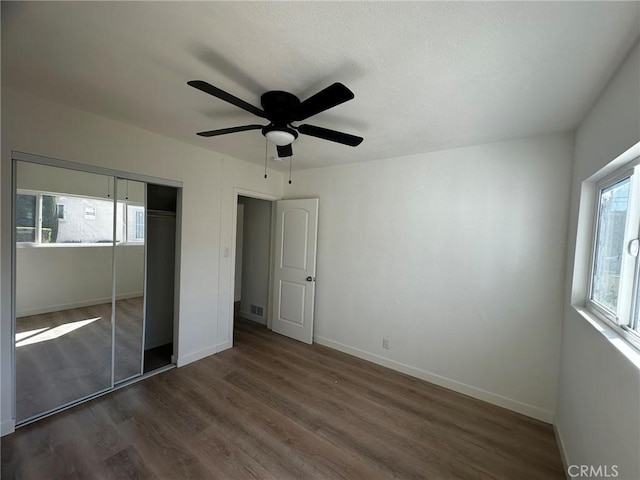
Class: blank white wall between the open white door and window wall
285,134,572,422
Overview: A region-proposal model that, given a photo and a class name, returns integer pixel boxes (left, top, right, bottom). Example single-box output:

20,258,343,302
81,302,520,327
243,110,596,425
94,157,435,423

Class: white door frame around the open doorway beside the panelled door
228,187,282,347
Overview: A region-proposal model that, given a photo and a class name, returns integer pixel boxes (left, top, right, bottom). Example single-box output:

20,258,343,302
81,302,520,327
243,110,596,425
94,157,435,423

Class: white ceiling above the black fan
2,1,640,168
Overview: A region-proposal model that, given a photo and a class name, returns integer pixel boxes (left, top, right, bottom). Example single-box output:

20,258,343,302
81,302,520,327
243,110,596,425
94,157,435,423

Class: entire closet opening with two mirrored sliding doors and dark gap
13,158,179,425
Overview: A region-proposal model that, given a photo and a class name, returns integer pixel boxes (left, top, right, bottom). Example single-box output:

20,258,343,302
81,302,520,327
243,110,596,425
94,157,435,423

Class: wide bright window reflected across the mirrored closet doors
16,191,145,245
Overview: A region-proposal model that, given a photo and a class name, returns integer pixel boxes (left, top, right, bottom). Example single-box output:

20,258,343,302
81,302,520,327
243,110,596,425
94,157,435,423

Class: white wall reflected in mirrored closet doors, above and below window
16,158,144,317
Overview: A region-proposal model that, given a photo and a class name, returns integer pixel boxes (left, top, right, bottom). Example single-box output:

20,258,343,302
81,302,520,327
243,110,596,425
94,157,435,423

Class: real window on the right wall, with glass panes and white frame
587,159,640,347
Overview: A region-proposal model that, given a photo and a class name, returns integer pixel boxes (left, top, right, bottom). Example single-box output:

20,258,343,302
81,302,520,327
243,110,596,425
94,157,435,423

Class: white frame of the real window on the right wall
584,156,640,350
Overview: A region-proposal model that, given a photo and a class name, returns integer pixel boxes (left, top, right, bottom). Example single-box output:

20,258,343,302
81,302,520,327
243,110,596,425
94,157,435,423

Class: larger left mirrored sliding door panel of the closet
14,162,115,422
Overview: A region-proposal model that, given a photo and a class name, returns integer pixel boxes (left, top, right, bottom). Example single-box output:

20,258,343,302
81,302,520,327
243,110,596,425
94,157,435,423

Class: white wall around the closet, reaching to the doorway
0,88,283,433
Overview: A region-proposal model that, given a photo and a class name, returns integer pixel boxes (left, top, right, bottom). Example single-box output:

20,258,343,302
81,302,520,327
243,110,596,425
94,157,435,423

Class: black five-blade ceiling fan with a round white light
187,80,363,158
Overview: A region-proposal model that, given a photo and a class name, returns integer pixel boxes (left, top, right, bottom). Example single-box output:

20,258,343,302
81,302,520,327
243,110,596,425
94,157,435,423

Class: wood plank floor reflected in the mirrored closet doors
16,297,148,421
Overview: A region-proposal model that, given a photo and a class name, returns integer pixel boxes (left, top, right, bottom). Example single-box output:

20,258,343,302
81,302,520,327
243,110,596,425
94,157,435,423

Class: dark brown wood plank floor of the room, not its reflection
2,321,565,480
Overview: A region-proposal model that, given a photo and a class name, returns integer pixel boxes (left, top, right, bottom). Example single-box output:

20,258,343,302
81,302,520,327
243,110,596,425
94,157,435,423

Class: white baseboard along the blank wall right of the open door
313,336,553,423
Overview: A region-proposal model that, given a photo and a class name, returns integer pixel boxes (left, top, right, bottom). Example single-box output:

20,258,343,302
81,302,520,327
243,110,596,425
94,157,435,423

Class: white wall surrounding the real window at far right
556,41,640,479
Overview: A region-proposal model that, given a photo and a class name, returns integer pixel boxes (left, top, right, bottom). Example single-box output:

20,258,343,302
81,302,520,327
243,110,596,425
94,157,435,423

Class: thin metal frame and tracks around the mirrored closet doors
10,150,182,427
